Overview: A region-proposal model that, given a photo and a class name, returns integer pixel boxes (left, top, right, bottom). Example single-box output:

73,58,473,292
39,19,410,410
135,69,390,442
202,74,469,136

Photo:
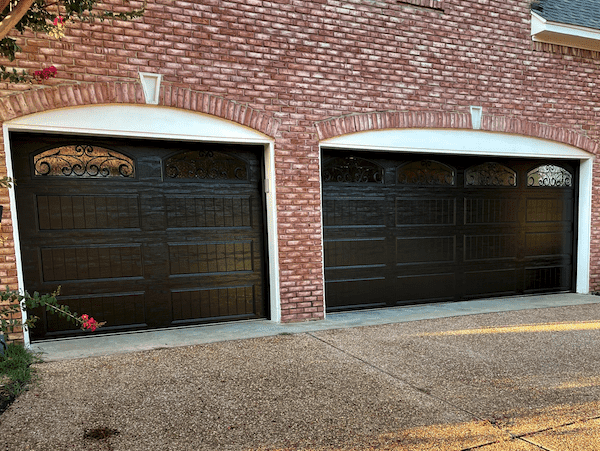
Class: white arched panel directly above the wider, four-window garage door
321,129,593,159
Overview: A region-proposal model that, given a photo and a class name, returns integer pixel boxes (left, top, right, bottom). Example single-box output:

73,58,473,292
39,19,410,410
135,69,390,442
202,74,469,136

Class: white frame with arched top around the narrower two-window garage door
3,105,281,346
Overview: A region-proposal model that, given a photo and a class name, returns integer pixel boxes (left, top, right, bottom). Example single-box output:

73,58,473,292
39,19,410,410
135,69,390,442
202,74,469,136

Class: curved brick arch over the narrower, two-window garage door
0,82,279,137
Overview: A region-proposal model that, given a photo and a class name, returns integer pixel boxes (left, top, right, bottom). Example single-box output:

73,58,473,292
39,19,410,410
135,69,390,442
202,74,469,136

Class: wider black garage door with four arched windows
322,150,577,311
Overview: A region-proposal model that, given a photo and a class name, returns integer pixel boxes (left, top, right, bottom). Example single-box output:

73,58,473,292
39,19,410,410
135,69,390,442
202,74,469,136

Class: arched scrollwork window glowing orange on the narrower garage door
33,144,135,178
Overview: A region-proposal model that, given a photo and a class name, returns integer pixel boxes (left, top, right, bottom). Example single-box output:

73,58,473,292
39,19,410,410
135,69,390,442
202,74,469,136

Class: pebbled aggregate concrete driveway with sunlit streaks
0,303,600,451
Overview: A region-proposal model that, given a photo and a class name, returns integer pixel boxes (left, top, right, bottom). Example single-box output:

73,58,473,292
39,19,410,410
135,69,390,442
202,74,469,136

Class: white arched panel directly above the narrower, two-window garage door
5,105,272,143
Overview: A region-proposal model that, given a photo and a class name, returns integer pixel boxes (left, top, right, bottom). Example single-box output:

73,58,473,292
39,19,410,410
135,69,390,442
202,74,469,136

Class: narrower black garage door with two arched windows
10,133,266,339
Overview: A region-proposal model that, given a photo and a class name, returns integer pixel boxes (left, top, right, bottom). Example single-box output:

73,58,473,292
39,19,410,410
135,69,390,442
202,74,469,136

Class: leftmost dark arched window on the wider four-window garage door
323,156,383,183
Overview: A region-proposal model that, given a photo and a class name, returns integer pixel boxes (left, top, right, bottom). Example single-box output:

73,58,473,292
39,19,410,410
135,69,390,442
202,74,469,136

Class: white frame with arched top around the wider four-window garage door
320,129,594,314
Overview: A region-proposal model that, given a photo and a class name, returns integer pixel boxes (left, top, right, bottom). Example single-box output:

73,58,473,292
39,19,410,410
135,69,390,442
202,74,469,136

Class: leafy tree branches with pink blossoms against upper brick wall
0,0,147,83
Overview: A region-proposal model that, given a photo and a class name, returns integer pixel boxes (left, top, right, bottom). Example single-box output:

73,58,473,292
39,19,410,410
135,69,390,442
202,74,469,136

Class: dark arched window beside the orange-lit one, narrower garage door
165,150,248,180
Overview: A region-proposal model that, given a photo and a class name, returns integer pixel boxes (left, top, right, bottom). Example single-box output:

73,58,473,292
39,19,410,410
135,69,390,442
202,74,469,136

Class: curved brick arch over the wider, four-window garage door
316,111,598,154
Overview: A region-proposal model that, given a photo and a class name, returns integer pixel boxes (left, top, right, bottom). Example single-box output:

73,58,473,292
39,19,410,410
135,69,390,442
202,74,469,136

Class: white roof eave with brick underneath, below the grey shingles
531,11,600,50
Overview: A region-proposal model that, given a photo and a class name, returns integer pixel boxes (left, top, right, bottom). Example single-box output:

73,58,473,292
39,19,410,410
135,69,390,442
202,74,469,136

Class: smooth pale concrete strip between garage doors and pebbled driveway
31,293,600,361
